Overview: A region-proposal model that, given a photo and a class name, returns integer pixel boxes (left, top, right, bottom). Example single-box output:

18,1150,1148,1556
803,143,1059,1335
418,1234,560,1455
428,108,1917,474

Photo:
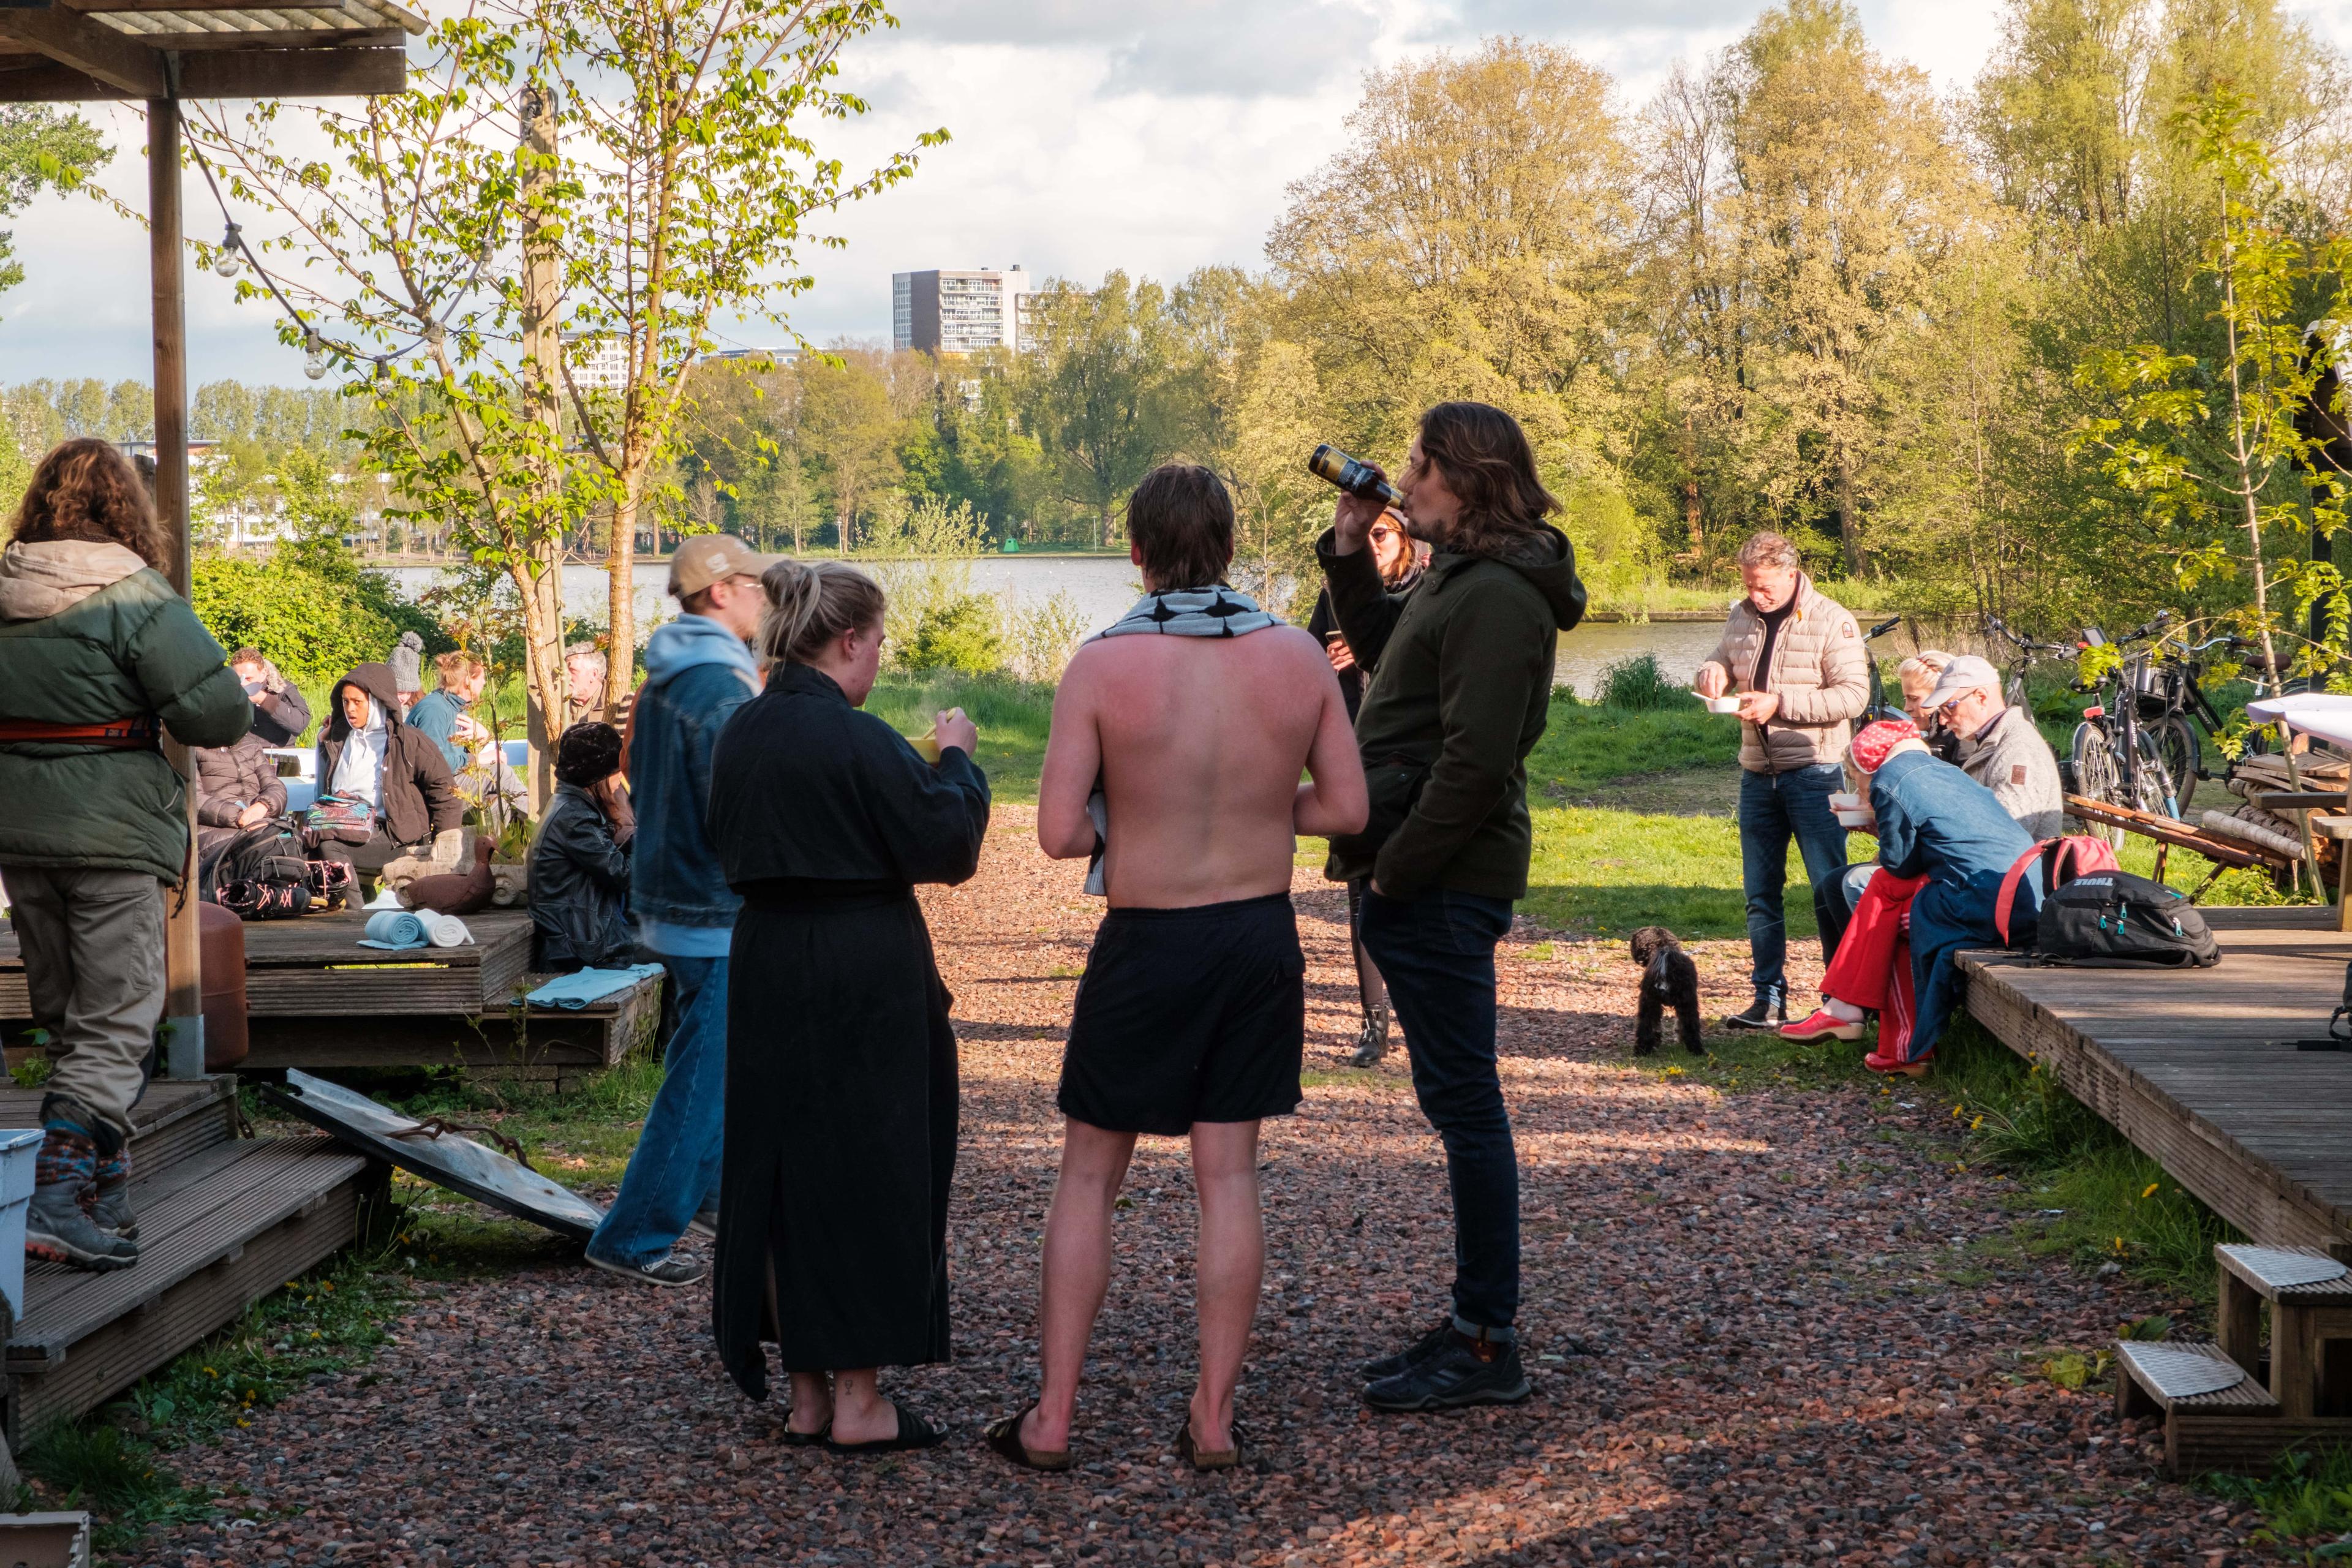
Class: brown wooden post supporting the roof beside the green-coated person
148,99,205,1077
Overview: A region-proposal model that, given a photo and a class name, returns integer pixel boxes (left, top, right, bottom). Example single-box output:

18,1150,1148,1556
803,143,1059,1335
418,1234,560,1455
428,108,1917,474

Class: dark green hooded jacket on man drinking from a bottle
1315,527,1585,898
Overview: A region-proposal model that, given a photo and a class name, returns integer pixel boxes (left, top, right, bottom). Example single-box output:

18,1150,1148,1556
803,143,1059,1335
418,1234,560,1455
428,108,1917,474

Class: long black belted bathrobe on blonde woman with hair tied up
708,665,988,1399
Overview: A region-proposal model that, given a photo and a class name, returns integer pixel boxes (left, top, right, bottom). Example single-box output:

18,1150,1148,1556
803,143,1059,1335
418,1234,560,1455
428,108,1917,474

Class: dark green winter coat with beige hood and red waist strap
0,541,254,884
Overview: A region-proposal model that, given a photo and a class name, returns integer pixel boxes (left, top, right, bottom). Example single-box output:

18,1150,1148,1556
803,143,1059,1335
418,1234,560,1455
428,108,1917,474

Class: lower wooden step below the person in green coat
5,1136,381,1444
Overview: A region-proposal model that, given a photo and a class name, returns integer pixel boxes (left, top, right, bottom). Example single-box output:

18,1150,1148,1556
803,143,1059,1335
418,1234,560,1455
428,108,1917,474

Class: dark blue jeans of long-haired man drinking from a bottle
1364,889,1520,1329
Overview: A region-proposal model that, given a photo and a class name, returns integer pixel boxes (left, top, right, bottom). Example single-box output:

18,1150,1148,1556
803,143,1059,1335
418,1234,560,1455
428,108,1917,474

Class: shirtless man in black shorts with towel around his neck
988,463,1366,1469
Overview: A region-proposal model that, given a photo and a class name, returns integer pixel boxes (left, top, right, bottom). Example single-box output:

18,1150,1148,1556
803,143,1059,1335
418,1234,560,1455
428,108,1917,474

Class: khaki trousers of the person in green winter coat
0,865,165,1138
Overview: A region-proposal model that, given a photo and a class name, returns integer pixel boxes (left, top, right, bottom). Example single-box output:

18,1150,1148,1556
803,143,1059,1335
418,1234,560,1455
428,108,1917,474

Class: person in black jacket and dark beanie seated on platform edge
531,724,638,973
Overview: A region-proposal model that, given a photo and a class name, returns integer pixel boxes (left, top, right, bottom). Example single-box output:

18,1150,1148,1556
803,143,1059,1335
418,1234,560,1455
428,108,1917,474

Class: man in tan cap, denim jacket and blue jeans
588,533,774,1286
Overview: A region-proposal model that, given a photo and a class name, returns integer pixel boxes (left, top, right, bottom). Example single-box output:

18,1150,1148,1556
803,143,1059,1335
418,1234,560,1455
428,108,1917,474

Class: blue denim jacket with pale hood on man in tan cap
628,616,753,926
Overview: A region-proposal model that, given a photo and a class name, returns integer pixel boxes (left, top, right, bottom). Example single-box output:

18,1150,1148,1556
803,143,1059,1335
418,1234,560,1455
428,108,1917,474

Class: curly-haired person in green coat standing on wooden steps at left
0,437,254,1270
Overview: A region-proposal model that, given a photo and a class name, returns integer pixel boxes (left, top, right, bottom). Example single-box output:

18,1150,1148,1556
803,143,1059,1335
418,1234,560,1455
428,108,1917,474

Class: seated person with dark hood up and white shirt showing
313,663,466,881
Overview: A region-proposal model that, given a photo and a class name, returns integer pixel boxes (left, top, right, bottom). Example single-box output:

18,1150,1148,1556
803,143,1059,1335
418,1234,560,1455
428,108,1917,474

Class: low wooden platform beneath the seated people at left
0,910,661,1088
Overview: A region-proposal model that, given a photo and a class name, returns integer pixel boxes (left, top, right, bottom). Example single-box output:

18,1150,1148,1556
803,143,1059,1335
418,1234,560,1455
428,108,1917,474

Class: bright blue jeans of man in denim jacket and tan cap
588,954,727,1270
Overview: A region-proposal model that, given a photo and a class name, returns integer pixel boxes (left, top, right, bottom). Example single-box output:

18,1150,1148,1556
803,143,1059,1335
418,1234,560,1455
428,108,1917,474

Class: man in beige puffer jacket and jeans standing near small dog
1698,533,1870,1030
